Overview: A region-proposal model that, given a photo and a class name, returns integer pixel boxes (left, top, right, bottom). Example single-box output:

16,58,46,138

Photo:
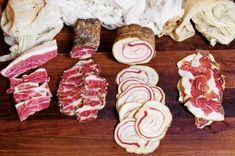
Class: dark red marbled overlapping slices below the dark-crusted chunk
57,59,108,122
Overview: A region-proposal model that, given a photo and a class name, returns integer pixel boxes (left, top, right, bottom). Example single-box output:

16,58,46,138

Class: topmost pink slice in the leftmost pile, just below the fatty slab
7,68,49,94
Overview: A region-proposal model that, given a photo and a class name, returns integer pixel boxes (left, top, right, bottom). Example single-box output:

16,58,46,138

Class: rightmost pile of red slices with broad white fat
177,50,225,128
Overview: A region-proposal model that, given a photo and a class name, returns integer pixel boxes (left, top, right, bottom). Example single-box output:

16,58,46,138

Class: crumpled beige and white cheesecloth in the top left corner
0,0,63,61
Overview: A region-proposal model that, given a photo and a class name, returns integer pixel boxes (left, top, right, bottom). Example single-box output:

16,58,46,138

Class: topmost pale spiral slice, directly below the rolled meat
116,65,159,86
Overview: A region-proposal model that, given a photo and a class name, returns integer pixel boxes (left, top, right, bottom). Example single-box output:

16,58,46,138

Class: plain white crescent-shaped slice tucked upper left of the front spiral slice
118,102,143,121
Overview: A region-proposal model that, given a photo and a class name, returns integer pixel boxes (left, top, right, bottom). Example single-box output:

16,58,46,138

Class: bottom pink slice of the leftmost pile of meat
15,96,50,121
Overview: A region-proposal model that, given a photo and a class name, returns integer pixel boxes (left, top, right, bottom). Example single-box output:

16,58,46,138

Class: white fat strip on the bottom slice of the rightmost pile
185,101,224,121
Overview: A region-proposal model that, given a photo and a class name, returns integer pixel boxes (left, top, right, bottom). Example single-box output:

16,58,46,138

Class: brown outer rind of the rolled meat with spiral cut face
115,24,155,51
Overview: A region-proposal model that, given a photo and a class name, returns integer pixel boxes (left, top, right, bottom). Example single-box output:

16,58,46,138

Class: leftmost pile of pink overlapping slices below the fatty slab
7,68,52,121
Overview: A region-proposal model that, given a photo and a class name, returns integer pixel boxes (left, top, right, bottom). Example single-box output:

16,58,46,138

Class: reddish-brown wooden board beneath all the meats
0,27,235,156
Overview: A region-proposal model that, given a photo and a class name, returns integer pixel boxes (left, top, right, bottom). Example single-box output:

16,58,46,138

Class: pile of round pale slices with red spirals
114,65,172,154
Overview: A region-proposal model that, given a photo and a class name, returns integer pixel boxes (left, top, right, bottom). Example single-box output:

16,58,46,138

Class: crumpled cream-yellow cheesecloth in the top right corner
169,0,235,46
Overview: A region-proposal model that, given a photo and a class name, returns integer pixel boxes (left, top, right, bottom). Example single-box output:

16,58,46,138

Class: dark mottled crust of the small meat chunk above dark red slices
74,18,101,50
